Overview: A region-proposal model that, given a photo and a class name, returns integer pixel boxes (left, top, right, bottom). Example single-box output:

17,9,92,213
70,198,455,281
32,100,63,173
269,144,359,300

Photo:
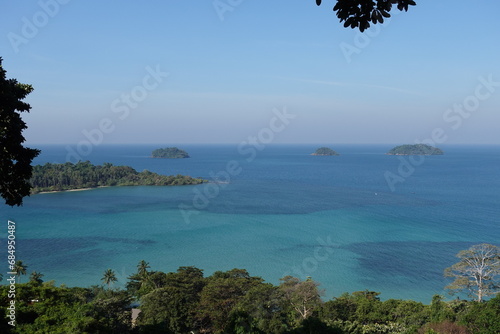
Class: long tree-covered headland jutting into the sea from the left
30,161,205,194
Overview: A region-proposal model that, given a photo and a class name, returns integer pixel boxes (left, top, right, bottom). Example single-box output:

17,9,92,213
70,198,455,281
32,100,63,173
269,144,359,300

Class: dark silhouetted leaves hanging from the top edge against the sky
316,0,416,32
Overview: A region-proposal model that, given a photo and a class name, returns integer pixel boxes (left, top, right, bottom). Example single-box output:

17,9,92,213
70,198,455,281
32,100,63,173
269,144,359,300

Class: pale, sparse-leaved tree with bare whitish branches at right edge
445,244,500,302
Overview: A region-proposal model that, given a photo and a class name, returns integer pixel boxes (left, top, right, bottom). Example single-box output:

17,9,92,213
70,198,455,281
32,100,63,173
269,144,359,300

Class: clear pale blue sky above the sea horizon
0,0,500,146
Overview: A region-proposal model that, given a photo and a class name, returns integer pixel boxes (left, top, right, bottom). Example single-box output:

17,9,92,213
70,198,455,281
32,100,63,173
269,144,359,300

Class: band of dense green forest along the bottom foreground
0,260,500,334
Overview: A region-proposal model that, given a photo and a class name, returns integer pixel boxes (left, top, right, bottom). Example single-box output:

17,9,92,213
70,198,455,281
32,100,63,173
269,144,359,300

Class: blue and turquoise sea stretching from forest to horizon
0,143,500,303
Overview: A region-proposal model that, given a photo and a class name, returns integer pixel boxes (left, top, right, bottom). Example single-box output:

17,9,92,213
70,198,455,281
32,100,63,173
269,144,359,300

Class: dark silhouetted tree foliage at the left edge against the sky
0,57,40,206
